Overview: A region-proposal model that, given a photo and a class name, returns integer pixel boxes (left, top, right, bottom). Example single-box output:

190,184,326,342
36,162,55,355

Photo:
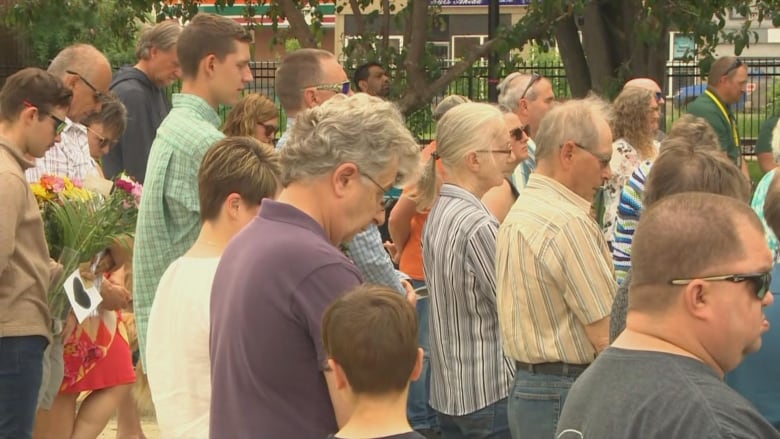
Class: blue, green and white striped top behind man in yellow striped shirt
612,160,653,285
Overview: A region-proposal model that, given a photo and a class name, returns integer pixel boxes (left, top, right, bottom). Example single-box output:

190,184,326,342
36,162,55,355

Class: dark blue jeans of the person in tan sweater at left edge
0,335,49,439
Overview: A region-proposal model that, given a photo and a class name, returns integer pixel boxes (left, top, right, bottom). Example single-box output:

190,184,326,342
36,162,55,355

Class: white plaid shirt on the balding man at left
25,118,100,183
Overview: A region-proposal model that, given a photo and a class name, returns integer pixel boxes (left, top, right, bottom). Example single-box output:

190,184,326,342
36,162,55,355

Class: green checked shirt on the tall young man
133,94,225,363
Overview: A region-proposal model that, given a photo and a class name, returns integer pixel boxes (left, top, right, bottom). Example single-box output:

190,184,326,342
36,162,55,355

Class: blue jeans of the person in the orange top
406,279,439,430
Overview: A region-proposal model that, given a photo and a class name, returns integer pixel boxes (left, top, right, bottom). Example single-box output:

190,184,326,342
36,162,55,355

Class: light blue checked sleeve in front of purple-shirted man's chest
349,223,406,295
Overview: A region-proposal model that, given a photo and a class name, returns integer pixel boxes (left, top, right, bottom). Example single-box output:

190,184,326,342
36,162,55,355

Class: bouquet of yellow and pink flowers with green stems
31,175,142,319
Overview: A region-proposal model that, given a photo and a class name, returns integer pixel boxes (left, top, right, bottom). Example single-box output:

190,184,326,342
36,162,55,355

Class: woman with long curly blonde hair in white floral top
596,87,661,249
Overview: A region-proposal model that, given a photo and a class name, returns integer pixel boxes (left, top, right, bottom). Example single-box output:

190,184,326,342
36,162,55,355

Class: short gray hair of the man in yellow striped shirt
534,95,612,161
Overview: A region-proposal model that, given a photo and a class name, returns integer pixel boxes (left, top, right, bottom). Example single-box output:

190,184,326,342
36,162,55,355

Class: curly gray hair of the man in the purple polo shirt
281,93,419,187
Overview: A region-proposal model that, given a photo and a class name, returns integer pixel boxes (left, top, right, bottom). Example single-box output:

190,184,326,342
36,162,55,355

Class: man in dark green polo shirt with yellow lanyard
688,56,750,178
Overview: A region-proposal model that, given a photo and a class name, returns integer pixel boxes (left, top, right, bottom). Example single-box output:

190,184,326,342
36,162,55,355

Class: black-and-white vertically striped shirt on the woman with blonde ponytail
422,184,514,416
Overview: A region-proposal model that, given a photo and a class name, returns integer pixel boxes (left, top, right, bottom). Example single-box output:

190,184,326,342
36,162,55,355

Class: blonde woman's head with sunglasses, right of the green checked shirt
222,93,279,145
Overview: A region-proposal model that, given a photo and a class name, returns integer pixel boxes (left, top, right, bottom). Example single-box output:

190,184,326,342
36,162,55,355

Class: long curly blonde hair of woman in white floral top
612,87,655,158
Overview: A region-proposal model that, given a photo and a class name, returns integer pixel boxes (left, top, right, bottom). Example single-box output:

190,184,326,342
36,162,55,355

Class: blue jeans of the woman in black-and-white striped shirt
439,398,511,439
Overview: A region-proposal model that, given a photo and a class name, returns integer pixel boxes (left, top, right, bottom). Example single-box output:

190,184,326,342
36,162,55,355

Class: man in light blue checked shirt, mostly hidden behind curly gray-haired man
276,49,411,293
